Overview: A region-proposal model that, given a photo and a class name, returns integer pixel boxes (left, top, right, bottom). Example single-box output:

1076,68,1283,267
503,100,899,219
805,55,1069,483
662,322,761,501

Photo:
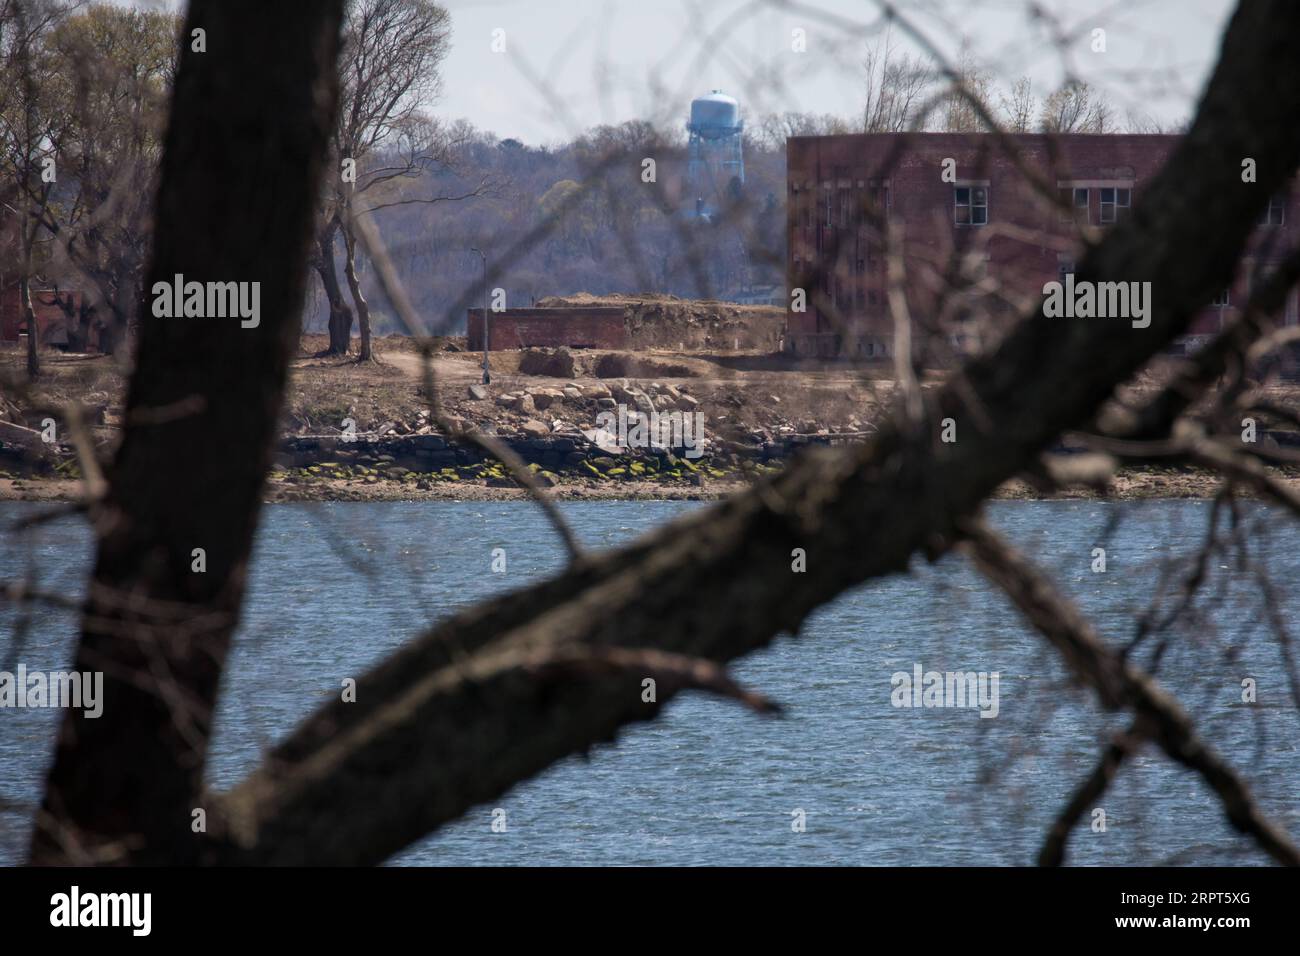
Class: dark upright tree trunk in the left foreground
31,0,343,864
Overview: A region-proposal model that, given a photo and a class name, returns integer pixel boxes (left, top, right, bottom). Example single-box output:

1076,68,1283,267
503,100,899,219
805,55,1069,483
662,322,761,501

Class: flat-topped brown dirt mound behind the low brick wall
537,293,785,351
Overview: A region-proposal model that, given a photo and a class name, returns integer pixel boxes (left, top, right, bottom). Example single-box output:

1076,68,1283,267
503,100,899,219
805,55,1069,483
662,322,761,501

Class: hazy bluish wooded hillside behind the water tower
327,122,785,334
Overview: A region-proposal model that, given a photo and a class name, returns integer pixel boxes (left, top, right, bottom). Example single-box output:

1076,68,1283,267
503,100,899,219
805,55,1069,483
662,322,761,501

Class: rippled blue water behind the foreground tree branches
0,501,1300,865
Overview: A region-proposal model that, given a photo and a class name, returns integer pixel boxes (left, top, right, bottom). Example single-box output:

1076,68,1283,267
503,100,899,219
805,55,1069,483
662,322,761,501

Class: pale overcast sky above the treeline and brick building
137,0,1234,144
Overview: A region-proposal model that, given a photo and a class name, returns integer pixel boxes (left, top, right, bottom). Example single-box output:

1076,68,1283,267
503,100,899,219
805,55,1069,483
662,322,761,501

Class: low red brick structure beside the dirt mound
467,306,629,351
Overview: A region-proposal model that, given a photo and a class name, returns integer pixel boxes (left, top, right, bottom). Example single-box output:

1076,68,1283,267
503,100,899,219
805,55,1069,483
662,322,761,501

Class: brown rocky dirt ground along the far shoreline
0,336,1300,501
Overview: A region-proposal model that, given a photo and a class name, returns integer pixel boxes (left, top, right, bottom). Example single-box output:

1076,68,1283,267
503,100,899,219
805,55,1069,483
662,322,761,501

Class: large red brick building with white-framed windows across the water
785,133,1300,358
